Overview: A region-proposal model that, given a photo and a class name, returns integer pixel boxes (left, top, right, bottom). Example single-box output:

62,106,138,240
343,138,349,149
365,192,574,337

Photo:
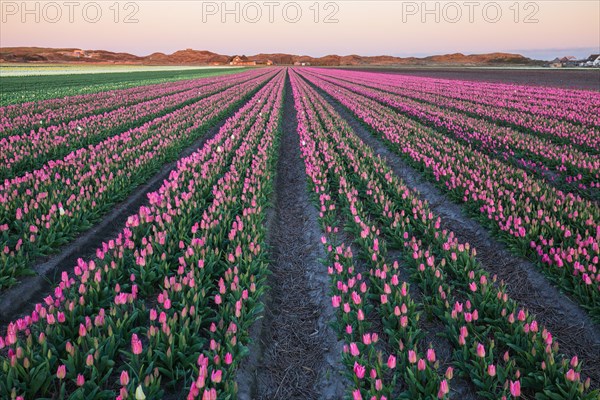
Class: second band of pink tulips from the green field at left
0,70,272,180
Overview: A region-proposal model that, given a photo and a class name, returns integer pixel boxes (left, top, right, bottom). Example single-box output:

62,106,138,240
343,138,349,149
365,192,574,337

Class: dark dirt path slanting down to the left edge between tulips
0,101,246,327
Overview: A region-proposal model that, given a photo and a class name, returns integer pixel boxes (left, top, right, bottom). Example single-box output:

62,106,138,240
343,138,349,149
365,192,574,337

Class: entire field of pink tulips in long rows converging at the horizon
0,67,600,400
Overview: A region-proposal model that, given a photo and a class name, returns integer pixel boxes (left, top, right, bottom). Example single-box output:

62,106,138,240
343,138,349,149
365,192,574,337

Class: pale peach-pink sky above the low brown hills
0,0,600,59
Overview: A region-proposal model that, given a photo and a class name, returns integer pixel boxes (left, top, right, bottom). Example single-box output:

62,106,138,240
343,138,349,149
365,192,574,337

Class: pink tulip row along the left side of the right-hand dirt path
290,67,598,399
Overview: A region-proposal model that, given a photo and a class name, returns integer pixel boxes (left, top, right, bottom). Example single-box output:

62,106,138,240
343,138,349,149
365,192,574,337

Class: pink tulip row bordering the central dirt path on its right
292,70,449,400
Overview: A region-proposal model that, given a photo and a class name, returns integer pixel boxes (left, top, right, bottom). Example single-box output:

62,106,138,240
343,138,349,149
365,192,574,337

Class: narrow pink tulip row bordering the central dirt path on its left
187,74,284,399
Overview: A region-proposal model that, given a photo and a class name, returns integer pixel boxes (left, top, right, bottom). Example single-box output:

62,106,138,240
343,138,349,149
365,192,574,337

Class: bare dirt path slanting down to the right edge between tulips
313,80,600,388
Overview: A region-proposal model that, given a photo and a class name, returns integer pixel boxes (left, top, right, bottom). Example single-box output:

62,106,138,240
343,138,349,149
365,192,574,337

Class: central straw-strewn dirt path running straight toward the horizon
237,74,346,400
